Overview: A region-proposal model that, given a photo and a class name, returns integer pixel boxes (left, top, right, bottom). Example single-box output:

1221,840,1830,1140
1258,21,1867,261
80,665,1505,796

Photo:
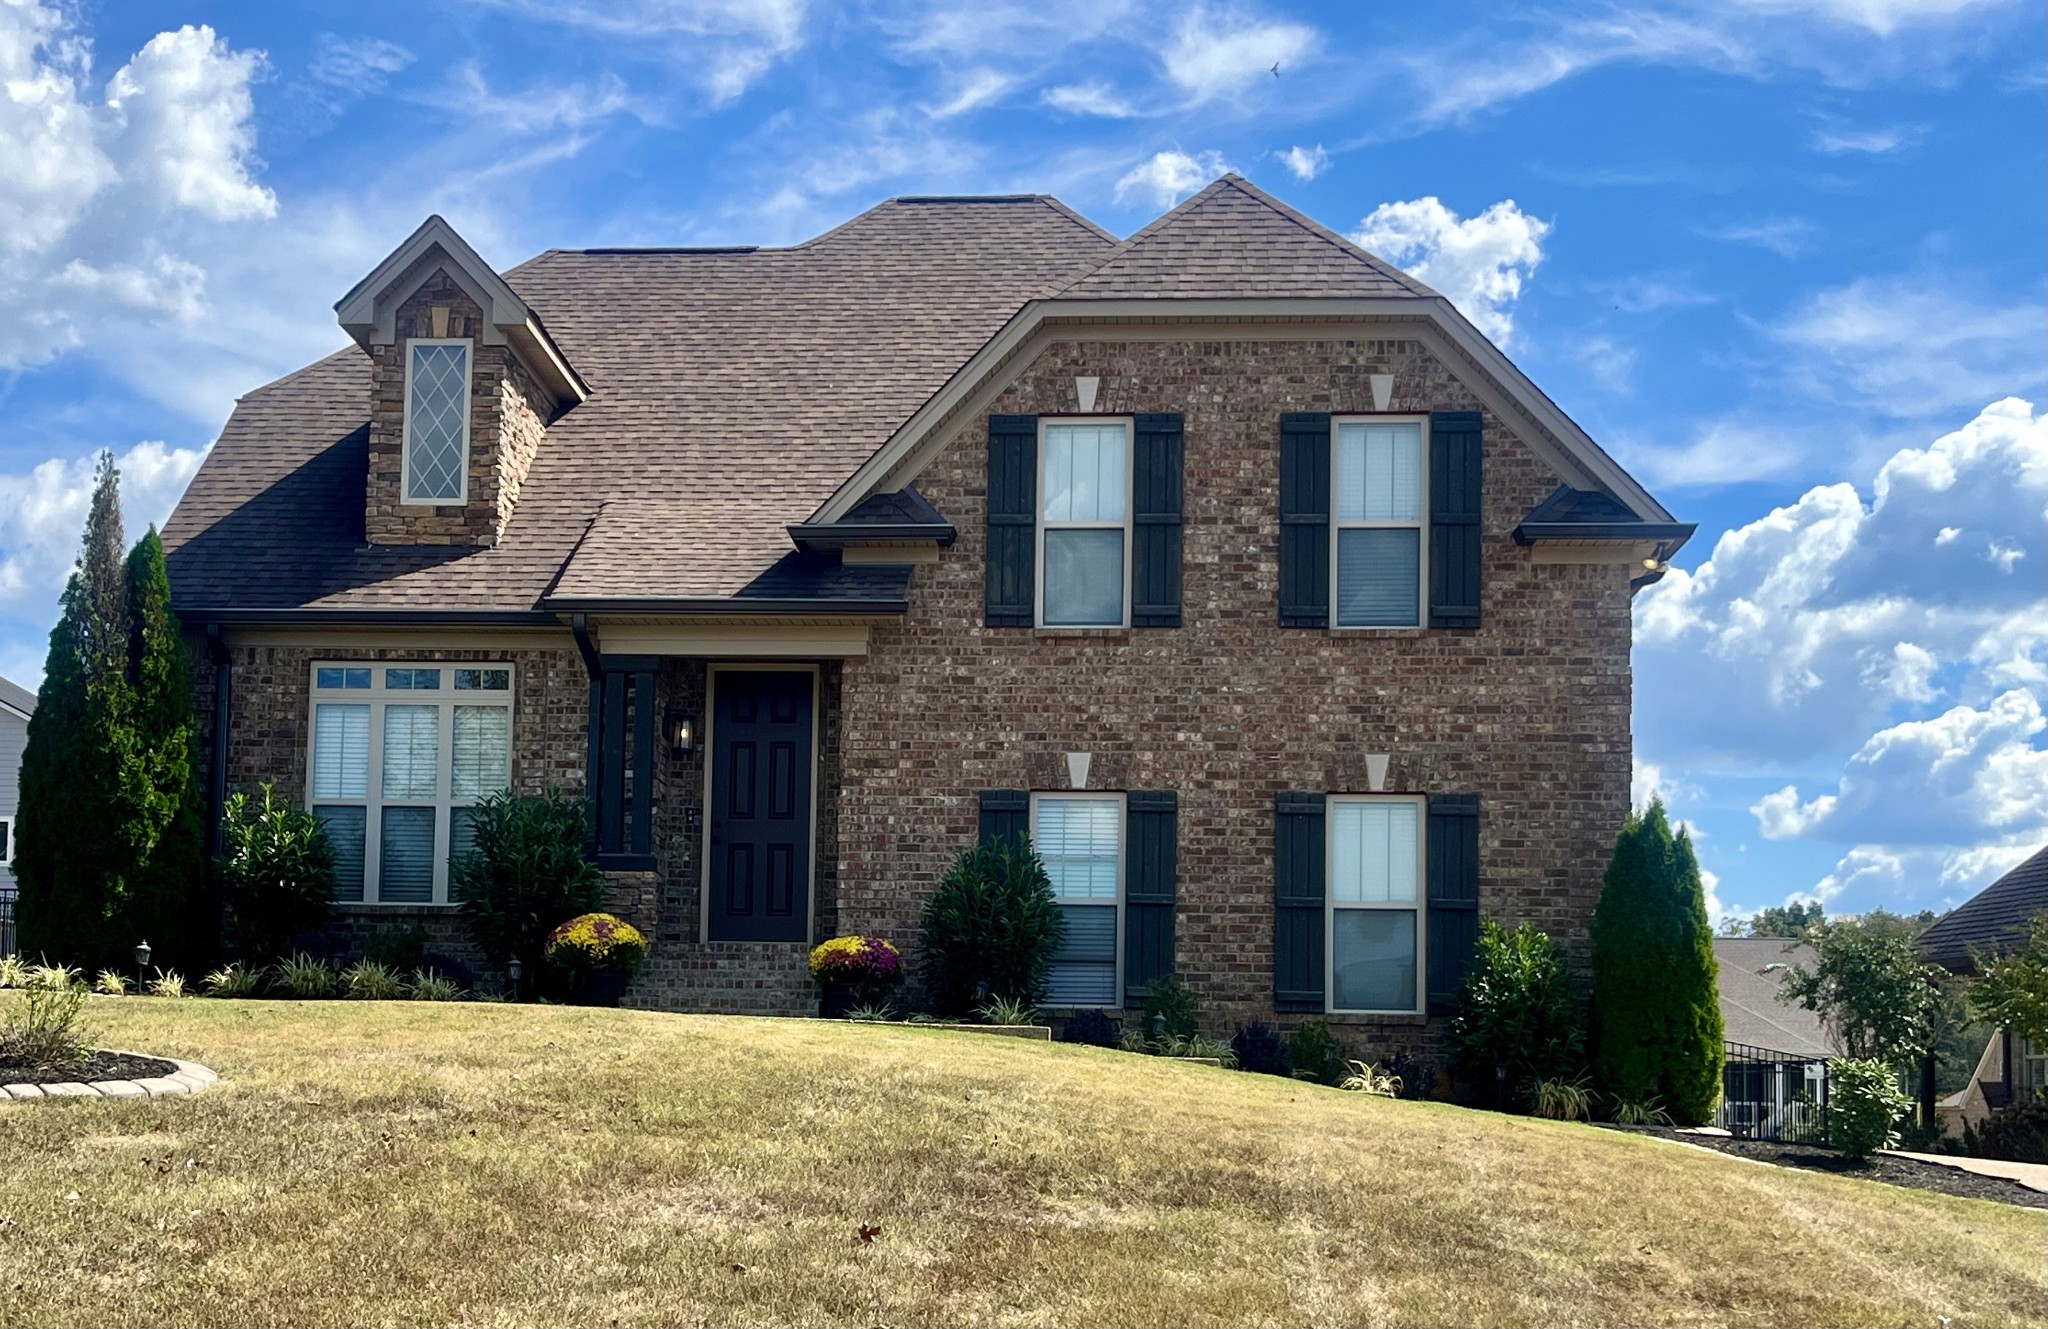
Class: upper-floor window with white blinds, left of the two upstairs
1038,420,1130,627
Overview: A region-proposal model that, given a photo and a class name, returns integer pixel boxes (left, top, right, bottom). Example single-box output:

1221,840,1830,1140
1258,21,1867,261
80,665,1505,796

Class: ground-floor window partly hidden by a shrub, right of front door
1030,795,1124,1005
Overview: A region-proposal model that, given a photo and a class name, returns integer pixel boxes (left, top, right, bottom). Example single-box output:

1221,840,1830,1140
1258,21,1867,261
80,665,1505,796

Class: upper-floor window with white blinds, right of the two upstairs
1329,418,1427,627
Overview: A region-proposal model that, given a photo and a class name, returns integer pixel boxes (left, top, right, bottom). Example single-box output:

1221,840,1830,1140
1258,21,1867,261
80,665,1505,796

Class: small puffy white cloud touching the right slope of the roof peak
1352,195,1550,346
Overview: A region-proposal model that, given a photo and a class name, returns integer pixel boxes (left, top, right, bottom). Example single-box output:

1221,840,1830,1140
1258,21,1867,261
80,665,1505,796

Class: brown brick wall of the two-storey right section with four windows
836,340,1630,1051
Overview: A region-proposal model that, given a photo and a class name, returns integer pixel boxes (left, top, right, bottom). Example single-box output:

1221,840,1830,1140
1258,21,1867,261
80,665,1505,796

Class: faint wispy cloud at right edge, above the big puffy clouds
1769,276,2048,420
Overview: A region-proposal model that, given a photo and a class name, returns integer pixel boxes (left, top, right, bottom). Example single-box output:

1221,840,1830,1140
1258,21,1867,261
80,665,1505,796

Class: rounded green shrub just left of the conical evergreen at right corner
1450,917,1585,1108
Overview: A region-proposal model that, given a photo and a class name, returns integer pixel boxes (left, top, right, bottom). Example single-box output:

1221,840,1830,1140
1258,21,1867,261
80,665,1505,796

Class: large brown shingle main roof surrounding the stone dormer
164,197,1114,610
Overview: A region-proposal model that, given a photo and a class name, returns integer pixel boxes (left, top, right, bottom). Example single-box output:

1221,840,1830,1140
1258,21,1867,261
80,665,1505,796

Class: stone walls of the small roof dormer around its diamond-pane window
362,272,553,547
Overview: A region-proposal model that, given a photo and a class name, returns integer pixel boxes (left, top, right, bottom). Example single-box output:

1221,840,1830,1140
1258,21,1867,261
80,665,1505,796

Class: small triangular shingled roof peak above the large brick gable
1061,176,1436,299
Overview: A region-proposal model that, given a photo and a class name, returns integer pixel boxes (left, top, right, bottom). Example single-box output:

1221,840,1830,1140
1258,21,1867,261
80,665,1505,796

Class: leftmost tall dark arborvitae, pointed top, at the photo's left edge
14,453,137,967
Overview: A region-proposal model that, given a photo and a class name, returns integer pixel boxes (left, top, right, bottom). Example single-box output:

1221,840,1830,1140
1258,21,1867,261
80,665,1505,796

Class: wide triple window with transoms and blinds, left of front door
309,663,512,905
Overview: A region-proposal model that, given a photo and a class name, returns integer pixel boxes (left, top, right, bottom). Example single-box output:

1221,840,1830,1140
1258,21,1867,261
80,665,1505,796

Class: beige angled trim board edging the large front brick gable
809,297,1673,522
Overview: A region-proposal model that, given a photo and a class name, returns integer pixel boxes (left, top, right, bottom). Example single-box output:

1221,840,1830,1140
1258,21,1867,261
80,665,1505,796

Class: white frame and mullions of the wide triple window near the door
305,659,518,909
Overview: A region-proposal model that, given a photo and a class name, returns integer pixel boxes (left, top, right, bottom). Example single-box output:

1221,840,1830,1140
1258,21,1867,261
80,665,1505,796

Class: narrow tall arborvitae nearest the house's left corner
123,526,217,973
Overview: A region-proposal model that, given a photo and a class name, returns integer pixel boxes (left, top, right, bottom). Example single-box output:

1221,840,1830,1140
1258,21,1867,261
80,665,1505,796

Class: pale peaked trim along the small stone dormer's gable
334,215,590,408
